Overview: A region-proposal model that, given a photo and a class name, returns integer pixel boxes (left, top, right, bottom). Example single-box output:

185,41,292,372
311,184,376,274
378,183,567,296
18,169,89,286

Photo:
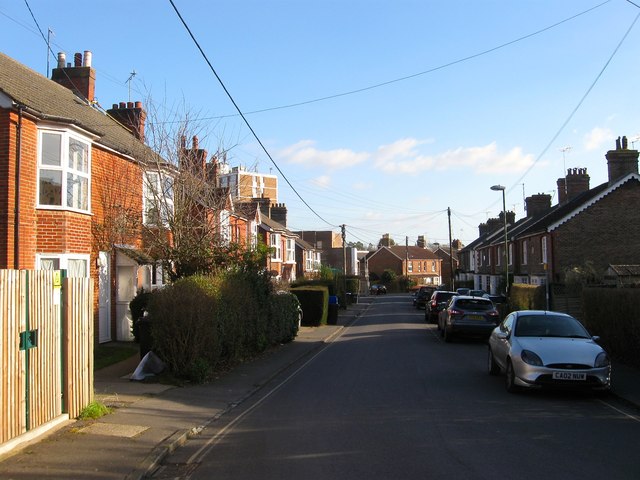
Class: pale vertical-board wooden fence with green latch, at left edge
0,270,93,445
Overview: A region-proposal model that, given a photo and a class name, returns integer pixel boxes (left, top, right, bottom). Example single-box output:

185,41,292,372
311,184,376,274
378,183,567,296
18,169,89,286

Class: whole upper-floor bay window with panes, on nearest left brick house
38,130,91,212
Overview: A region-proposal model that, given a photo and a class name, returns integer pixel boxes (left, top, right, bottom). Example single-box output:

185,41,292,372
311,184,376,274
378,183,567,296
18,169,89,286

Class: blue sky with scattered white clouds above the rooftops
0,0,640,245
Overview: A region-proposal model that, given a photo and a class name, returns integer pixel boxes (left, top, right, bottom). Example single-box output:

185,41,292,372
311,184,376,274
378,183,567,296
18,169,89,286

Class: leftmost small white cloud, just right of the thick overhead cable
278,140,370,169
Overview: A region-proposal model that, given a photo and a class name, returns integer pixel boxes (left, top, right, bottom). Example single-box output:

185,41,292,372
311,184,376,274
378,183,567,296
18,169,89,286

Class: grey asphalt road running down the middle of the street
154,295,640,480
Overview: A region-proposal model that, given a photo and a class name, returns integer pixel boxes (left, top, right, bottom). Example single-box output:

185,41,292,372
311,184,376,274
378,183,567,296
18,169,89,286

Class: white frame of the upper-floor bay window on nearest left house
36,128,91,213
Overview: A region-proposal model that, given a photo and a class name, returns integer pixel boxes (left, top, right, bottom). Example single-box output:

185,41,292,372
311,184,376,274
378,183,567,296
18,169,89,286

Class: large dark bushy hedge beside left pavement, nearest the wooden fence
148,272,299,382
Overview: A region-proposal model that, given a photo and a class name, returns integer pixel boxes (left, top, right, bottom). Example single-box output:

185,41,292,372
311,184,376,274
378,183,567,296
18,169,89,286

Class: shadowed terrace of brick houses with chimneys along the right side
465,138,640,293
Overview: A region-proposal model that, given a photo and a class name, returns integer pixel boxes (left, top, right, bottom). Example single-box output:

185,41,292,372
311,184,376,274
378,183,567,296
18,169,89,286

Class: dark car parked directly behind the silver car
438,295,500,342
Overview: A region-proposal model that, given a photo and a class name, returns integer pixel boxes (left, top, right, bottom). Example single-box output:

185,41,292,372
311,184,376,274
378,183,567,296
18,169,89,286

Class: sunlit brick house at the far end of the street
363,245,442,286
